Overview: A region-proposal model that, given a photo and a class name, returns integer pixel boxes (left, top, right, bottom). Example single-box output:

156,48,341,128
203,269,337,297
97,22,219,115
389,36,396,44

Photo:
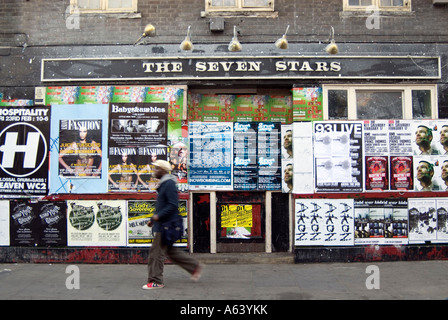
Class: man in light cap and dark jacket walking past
142,160,203,290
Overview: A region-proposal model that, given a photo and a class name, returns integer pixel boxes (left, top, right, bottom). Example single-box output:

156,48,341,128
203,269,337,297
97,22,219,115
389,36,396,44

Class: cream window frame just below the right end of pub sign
322,84,439,120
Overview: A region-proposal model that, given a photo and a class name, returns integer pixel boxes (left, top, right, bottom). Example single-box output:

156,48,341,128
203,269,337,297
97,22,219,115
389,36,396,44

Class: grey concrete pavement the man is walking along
0,261,448,301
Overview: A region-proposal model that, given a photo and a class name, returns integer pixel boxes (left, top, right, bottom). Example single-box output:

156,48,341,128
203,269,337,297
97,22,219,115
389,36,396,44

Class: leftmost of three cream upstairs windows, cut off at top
70,0,137,13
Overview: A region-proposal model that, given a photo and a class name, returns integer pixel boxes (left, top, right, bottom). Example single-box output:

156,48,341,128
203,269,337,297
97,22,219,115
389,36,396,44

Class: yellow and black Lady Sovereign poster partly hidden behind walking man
127,200,188,247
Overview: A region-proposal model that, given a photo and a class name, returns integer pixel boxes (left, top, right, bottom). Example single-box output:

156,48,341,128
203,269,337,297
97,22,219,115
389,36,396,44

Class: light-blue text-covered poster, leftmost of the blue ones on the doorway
188,122,233,190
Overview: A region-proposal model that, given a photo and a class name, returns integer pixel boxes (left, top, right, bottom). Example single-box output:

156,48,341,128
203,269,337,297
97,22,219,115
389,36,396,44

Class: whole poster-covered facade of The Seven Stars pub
0,0,448,262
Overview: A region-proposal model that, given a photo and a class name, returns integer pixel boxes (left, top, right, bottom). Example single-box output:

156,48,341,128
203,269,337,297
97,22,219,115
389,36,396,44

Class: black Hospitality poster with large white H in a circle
0,107,50,197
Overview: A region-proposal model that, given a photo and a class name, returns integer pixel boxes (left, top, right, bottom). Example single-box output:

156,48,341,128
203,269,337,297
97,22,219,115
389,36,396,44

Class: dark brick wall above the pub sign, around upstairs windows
0,0,448,46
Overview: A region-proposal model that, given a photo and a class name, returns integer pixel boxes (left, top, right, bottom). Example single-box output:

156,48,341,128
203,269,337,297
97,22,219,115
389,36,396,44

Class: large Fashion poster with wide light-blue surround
50,104,108,194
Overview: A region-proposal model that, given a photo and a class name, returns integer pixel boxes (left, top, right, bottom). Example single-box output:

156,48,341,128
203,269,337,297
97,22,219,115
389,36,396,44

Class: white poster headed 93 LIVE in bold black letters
314,121,364,192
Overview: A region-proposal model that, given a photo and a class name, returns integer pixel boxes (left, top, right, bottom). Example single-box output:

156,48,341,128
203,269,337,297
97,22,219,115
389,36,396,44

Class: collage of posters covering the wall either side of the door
0,86,448,245
